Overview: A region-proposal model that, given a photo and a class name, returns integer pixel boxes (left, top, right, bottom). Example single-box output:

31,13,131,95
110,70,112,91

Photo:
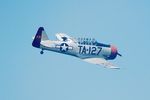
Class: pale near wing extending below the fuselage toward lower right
83,58,119,69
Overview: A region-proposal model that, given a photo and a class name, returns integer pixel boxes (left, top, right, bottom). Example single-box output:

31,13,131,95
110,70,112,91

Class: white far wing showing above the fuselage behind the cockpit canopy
56,33,76,42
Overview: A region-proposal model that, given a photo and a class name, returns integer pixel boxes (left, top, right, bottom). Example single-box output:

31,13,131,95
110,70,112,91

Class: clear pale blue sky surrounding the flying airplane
0,0,150,100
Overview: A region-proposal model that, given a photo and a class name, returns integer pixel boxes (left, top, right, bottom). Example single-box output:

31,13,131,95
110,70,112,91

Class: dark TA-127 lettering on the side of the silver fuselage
78,45,102,55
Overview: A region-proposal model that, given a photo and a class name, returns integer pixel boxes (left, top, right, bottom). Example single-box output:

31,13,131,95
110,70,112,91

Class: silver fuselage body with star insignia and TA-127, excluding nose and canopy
40,40,111,58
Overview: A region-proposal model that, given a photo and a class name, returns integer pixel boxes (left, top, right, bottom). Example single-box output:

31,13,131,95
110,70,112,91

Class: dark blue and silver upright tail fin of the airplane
32,27,49,48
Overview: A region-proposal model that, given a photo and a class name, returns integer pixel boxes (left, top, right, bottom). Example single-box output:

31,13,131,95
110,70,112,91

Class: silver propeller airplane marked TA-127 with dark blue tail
32,27,122,69
